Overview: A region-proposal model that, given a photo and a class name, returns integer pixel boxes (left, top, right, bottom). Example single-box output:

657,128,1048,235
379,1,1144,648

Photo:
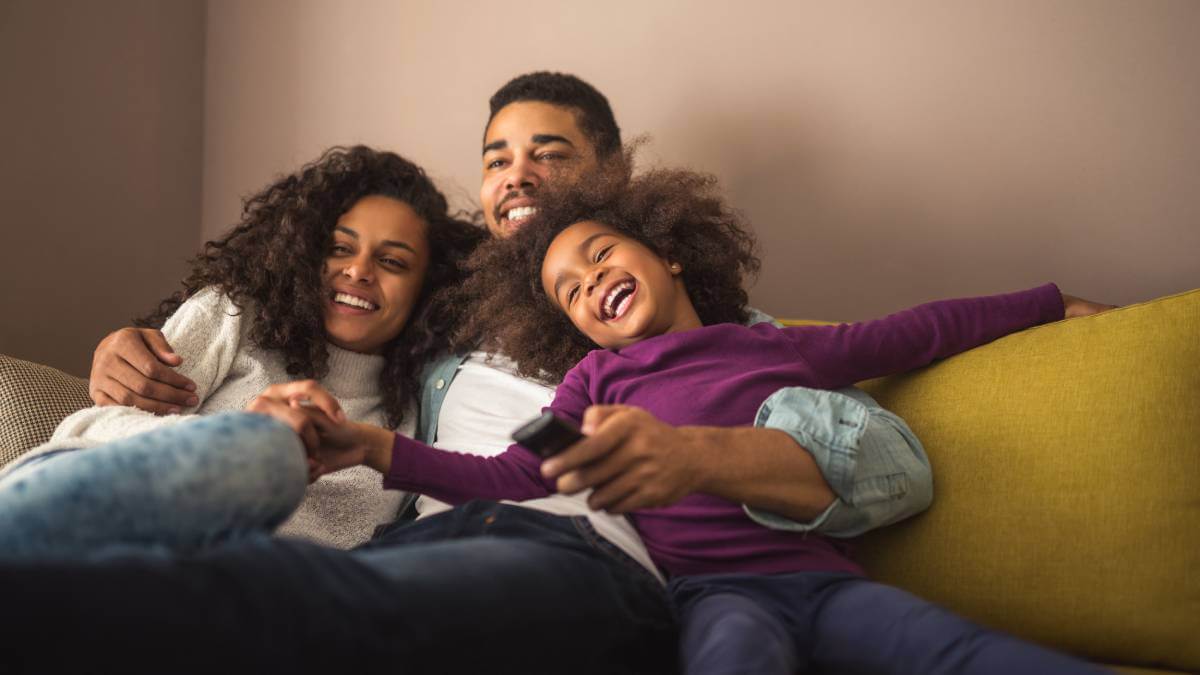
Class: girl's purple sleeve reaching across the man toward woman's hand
383,360,587,504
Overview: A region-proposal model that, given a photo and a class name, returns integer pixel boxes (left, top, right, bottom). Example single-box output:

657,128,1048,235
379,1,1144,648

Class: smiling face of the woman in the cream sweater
324,196,430,354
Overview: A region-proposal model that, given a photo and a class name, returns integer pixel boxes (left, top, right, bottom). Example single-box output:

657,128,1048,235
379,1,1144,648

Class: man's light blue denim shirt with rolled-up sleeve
416,309,934,537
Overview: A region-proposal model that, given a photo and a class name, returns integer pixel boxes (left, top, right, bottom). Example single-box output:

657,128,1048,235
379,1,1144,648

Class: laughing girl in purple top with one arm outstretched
307,164,1096,673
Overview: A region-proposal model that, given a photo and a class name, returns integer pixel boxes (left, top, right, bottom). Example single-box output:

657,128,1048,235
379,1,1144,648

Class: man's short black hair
485,71,620,159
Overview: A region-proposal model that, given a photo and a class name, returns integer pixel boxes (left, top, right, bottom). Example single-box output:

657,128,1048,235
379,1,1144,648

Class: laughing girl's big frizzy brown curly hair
448,157,760,383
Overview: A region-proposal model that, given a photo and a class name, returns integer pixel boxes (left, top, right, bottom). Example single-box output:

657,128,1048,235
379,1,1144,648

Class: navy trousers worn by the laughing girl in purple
670,572,1105,675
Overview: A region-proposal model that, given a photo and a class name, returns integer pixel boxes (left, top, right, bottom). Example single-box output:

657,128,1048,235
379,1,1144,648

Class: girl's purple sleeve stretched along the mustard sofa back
784,283,1063,389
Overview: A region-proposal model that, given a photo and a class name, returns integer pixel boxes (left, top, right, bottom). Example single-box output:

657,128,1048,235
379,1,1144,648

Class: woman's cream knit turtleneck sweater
13,288,416,548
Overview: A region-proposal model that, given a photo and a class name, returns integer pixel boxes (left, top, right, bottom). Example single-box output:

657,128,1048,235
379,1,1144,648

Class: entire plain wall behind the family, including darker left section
0,0,1200,370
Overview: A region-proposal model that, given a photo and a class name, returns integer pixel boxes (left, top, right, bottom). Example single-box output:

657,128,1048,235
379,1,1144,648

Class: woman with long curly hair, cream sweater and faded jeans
0,147,485,557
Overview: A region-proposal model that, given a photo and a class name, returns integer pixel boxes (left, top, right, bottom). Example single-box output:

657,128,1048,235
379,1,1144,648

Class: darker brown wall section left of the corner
0,0,204,375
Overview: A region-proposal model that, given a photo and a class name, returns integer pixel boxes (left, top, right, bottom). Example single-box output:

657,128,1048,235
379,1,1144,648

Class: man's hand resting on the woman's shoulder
88,328,199,414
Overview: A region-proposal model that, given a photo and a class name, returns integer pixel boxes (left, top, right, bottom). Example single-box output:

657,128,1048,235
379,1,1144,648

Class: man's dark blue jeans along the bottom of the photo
0,502,677,673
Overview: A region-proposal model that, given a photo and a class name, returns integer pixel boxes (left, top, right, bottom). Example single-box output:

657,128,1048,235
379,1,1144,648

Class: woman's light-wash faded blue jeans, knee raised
0,413,307,560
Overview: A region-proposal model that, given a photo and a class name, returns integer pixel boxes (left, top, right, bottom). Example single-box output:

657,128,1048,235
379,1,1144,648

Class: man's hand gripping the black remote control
541,406,702,513
